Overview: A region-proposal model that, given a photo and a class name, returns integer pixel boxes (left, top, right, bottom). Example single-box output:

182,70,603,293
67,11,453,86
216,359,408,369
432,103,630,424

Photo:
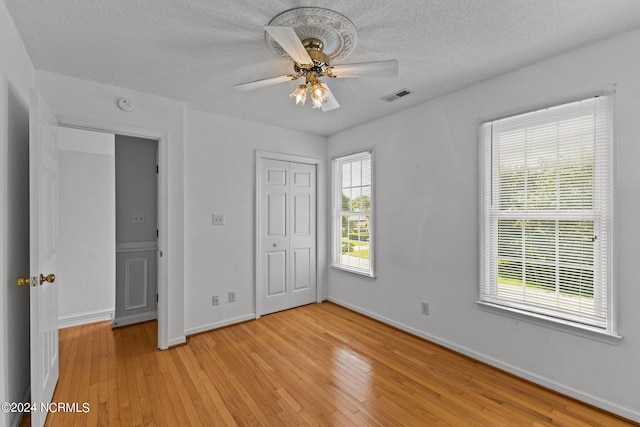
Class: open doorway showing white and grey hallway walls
58,127,158,327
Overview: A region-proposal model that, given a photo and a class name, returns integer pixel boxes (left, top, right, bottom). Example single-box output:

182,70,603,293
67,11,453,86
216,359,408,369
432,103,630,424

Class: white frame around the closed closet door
253,150,326,319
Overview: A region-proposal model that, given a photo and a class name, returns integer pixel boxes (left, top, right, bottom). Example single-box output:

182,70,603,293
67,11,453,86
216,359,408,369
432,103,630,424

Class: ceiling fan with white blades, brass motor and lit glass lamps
234,7,398,111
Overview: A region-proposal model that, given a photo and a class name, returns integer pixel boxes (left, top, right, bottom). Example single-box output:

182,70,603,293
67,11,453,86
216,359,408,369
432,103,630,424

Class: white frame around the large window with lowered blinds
476,93,622,344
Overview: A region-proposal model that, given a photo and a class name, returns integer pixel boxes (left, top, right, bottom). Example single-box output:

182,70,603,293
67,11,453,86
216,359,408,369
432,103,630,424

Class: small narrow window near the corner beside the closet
332,151,373,277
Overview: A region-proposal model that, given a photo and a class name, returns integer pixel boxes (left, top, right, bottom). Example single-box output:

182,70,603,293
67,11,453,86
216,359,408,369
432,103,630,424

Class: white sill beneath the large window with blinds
476,301,622,345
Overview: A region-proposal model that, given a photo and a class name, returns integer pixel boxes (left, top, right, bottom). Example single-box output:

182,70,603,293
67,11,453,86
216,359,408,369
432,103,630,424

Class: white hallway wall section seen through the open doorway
56,128,116,327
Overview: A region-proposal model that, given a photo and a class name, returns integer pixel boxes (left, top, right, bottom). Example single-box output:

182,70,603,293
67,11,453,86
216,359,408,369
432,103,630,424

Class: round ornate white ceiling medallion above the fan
265,7,358,62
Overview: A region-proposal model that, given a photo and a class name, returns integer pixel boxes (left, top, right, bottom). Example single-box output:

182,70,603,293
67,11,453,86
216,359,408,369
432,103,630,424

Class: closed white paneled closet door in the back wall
257,159,316,314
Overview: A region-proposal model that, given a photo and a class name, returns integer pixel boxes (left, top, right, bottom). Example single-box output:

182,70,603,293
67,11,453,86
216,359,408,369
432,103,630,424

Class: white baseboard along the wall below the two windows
327,297,640,422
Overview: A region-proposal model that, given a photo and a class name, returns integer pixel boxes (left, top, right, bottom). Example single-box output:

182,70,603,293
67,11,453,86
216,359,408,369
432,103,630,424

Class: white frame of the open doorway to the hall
56,115,169,350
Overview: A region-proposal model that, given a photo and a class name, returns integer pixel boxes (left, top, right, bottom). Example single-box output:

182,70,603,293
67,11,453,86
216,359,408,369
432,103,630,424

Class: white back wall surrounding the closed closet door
36,71,326,344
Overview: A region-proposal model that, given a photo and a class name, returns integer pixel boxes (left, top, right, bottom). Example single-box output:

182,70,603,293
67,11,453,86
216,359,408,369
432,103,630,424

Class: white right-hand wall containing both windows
328,31,640,421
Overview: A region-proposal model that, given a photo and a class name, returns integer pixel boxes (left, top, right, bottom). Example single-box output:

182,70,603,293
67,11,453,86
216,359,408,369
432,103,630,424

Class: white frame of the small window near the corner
331,148,376,280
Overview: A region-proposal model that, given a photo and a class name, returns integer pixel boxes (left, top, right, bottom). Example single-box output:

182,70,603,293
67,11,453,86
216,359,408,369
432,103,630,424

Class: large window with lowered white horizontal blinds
479,94,616,335
